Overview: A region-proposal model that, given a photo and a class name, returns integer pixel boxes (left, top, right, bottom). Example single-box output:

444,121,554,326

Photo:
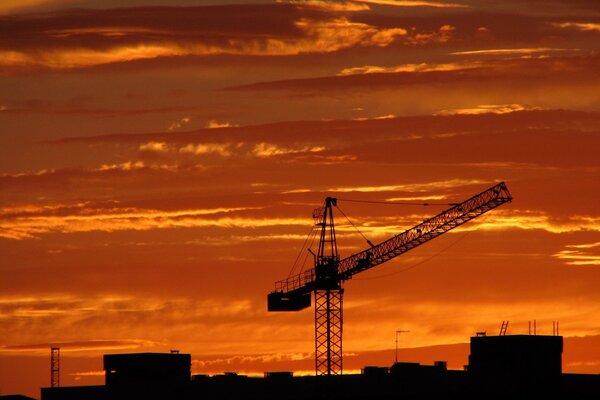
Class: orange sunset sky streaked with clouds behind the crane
0,0,600,397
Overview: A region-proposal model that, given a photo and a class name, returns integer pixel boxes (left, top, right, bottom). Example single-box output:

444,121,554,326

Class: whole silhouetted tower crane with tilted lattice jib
267,182,512,375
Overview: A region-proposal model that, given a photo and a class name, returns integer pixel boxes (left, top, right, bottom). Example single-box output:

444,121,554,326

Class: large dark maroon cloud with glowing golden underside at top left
0,3,406,70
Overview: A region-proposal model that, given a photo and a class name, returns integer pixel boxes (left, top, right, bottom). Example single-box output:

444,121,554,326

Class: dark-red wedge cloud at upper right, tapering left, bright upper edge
222,49,600,94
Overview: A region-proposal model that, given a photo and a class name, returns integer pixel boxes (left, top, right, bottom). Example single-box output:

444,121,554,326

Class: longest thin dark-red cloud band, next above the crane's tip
45,108,600,147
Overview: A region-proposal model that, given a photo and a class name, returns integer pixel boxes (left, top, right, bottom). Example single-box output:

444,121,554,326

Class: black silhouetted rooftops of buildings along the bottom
41,335,600,400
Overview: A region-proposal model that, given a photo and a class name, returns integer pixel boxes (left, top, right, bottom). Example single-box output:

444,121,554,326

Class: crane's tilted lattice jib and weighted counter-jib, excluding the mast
268,182,512,311
